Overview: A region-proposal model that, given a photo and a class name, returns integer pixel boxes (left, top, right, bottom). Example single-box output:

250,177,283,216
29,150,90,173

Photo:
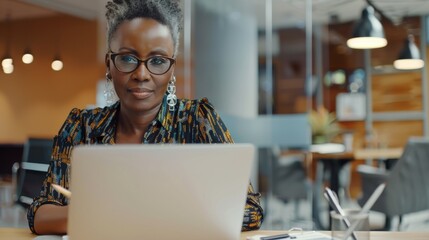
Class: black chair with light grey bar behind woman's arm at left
14,138,53,208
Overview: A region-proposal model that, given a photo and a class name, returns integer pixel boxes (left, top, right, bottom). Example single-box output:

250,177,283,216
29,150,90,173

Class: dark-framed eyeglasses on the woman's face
110,51,176,75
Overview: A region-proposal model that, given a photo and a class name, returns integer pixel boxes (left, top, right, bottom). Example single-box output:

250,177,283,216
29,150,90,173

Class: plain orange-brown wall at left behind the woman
0,14,99,143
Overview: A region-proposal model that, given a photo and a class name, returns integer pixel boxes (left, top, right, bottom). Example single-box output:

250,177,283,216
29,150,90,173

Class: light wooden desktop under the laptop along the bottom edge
5,228,429,240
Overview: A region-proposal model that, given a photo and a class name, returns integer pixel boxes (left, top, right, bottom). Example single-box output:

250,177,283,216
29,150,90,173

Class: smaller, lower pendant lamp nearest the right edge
393,35,425,70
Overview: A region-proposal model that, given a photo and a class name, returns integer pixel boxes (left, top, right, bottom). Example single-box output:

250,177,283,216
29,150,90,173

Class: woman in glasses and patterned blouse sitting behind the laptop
28,0,262,234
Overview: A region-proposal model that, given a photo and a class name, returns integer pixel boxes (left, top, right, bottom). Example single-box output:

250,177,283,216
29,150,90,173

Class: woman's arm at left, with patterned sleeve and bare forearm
27,109,82,234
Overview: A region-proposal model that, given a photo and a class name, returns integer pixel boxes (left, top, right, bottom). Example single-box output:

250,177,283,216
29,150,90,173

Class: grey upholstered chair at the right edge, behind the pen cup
357,138,429,230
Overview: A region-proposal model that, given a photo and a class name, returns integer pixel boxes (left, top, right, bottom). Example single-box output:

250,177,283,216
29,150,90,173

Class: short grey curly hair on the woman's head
106,0,183,55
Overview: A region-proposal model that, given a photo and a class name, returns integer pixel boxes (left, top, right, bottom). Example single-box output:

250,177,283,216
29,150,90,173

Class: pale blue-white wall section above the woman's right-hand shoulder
193,0,258,117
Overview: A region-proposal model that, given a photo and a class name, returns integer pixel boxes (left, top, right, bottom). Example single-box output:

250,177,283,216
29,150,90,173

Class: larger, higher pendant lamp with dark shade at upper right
347,6,387,49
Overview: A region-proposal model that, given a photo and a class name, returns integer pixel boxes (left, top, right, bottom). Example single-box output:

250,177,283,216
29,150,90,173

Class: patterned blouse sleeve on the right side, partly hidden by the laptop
197,98,263,231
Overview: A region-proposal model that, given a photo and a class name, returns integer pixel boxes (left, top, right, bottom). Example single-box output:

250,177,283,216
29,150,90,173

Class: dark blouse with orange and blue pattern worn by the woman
27,97,263,233
